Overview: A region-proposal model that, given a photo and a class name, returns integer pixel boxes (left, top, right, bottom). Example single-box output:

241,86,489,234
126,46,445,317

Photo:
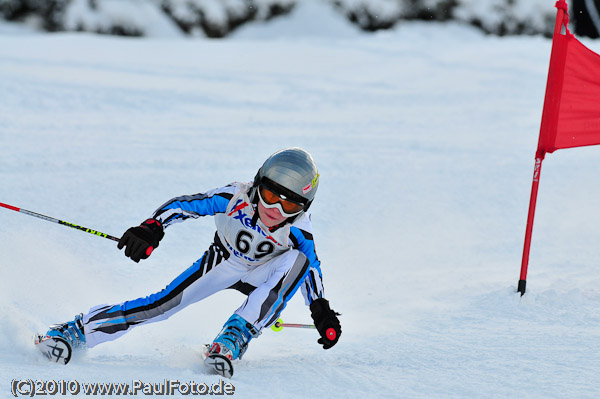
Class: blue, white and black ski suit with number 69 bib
83,183,323,347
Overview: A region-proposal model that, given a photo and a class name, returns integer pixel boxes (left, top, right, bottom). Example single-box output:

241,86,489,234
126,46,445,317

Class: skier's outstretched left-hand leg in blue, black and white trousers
83,245,247,347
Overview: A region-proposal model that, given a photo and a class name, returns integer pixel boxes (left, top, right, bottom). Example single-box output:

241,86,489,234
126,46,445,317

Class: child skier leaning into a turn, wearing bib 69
40,148,342,377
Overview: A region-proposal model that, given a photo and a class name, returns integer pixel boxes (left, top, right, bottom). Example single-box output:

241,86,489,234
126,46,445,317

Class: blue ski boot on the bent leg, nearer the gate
204,314,260,378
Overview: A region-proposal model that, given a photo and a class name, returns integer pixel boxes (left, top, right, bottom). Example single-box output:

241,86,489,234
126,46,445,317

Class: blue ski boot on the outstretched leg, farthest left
35,314,85,364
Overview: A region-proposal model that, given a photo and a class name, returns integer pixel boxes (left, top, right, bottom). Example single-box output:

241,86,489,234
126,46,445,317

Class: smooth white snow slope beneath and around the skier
0,3,600,399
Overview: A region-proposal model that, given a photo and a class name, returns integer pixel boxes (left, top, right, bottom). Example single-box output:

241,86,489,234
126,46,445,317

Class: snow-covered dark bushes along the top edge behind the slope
0,0,564,37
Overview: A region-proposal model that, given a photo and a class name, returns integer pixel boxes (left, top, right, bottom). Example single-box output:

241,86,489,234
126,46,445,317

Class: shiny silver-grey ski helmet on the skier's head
250,147,319,223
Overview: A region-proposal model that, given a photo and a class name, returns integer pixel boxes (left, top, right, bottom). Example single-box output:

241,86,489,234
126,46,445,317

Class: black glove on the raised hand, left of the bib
117,219,165,262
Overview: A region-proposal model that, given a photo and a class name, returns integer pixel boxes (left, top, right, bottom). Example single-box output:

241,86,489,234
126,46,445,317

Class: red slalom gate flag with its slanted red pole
518,0,600,295
